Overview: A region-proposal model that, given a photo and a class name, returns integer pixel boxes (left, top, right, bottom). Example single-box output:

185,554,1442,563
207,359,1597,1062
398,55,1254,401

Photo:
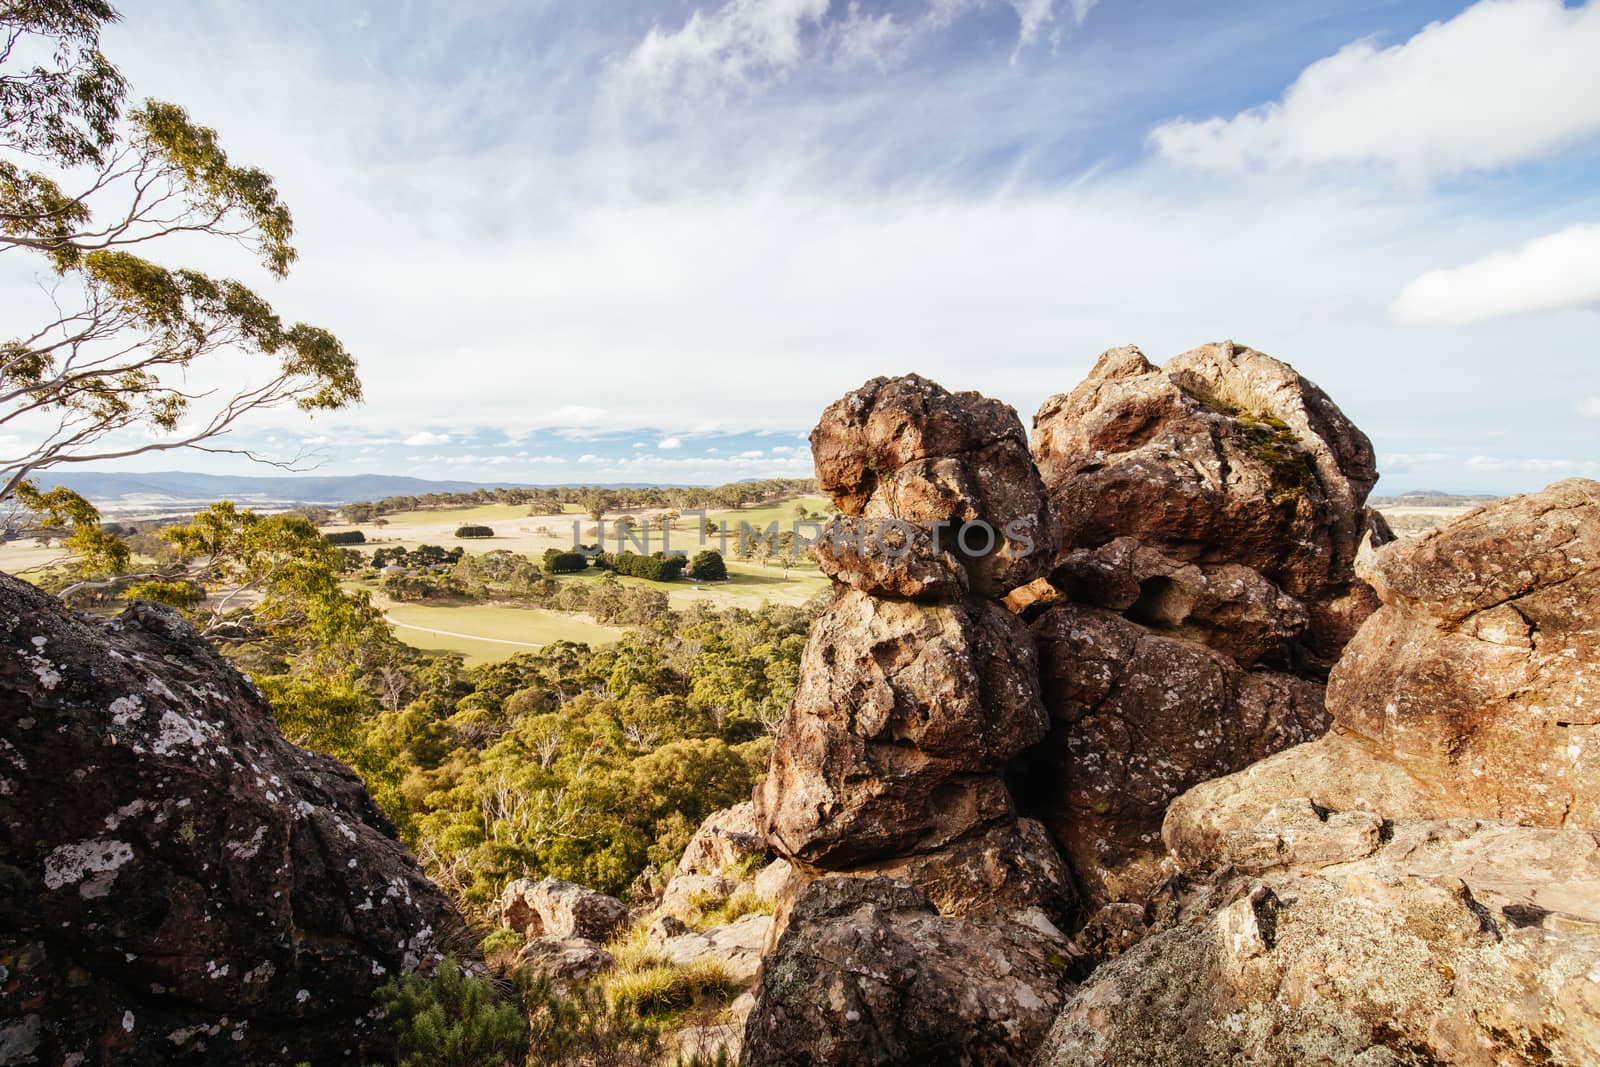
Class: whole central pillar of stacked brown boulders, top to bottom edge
746,376,1075,1064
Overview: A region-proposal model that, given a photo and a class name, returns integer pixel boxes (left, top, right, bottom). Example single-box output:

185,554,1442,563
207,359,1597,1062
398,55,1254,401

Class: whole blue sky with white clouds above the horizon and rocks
0,0,1600,493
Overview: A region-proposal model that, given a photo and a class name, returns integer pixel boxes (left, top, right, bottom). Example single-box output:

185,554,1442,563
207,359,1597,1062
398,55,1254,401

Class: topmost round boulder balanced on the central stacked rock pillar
811,374,1061,600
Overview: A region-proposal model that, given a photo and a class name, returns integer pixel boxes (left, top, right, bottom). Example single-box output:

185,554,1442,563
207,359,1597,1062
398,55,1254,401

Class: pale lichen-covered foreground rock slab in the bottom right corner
1037,812,1600,1067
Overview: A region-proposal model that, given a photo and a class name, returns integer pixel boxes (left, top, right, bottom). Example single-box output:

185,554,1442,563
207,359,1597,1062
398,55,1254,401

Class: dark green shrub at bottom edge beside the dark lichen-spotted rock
378,957,528,1067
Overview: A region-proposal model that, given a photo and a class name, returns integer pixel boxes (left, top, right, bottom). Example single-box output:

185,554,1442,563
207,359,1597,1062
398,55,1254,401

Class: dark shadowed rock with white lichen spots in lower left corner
0,576,470,1064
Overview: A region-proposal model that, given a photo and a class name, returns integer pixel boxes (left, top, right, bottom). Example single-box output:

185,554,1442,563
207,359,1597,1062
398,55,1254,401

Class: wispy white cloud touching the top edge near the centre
621,0,829,96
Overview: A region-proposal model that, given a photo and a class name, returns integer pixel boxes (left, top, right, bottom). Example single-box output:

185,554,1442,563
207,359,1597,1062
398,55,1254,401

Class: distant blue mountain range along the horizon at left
35,470,646,515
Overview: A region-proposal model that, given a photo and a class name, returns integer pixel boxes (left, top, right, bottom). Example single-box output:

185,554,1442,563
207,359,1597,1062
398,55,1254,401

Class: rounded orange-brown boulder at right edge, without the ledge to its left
1328,480,1600,827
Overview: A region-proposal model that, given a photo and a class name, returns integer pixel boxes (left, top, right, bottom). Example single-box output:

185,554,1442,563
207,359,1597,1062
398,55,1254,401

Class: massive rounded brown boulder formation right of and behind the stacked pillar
1010,342,1387,904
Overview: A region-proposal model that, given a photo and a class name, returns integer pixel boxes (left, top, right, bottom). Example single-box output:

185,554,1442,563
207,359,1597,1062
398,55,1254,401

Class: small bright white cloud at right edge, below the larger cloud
1394,226,1600,326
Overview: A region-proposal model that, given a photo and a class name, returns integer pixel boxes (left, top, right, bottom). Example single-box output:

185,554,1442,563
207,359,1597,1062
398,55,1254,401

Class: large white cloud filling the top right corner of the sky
1150,0,1600,181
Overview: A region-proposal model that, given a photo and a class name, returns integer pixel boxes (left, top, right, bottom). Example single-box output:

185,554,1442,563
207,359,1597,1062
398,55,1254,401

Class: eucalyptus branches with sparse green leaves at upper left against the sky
0,0,362,502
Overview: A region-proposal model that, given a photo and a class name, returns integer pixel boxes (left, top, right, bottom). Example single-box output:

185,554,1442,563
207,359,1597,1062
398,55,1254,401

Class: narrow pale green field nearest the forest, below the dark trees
384,605,622,664
